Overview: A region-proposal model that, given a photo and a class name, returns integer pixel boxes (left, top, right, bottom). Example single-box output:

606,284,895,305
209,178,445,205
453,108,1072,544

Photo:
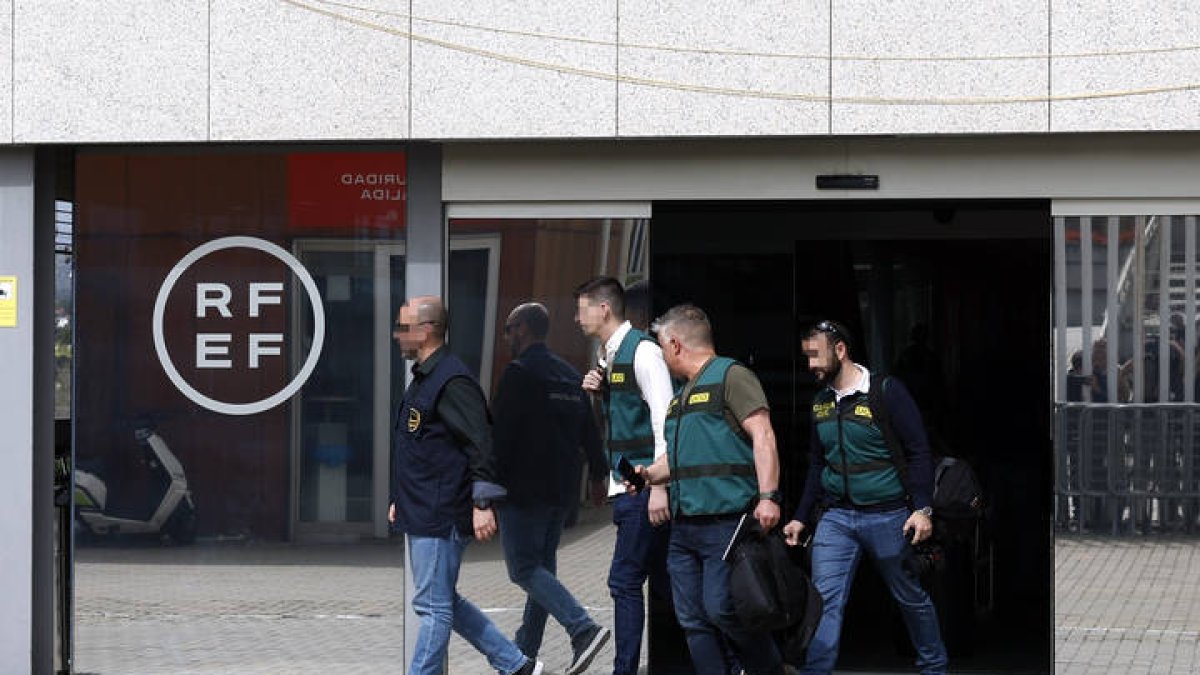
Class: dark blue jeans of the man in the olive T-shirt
667,514,784,675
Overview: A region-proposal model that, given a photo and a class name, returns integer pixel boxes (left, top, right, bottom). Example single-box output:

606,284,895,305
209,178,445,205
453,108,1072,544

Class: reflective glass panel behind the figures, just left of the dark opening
448,220,653,673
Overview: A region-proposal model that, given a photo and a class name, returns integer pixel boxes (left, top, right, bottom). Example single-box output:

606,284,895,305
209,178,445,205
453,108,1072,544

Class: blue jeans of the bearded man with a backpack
804,508,948,674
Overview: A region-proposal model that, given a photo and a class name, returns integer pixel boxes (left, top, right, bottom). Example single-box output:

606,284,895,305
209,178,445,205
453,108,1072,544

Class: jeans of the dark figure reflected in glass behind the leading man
500,504,594,657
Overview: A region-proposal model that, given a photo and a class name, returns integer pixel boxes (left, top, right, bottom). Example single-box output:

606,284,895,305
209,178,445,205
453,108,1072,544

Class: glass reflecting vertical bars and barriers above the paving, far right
1055,215,1200,532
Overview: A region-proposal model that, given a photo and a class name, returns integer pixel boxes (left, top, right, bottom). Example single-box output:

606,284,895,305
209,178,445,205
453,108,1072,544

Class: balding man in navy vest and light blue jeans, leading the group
388,295,542,675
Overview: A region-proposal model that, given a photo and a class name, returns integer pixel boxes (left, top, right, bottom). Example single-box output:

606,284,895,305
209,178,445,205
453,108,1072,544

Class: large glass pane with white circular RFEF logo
75,148,407,673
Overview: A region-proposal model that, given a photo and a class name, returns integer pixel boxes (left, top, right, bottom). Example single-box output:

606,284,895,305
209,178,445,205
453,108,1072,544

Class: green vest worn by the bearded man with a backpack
812,389,906,506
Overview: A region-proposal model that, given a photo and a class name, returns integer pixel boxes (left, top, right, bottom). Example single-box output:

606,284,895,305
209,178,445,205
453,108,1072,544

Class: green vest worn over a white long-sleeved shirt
605,328,654,483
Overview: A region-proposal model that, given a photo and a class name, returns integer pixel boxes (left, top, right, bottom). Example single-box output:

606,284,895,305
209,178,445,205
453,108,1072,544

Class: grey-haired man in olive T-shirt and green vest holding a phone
641,305,784,675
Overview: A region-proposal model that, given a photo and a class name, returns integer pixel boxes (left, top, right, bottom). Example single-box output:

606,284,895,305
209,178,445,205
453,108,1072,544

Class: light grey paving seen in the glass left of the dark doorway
74,509,613,675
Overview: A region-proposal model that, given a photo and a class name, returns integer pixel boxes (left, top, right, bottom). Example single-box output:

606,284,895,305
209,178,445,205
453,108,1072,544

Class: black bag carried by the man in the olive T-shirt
726,516,821,646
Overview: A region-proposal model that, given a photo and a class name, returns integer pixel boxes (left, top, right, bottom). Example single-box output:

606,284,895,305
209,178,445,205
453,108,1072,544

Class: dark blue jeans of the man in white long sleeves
608,490,670,675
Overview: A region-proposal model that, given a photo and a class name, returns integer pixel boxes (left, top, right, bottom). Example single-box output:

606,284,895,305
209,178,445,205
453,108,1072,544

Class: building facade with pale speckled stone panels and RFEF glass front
0,0,1200,673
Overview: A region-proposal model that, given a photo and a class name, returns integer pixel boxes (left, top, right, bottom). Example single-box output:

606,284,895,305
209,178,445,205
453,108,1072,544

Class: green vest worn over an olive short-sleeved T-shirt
665,357,758,515
